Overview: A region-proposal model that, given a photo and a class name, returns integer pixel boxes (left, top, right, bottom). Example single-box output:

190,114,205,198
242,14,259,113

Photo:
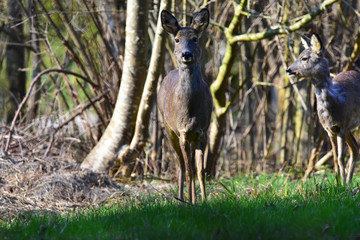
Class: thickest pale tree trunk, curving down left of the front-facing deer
81,0,148,172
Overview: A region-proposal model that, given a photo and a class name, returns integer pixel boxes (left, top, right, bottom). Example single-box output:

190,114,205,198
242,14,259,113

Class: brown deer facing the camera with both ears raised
157,8,213,204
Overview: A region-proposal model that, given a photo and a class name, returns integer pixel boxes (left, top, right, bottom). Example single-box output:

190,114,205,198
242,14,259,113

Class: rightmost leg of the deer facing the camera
195,135,207,201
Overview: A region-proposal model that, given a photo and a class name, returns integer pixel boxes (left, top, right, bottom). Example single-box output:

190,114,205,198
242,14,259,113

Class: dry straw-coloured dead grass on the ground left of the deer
0,151,174,220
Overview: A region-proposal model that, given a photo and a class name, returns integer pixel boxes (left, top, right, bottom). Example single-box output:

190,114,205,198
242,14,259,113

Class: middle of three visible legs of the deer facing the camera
180,132,194,203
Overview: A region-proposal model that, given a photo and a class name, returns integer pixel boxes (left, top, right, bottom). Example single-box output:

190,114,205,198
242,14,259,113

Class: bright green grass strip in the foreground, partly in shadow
0,175,360,239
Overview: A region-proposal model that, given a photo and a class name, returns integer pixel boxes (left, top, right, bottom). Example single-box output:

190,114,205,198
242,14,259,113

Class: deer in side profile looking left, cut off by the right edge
286,33,360,185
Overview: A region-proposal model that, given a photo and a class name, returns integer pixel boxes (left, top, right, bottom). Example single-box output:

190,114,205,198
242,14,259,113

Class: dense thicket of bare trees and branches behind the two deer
0,0,360,182
